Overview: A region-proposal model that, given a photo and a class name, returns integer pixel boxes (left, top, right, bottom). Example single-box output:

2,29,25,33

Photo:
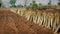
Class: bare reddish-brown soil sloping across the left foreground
0,10,54,34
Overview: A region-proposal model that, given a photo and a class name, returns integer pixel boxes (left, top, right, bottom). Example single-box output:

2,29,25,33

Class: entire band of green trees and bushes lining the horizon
0,0,60,9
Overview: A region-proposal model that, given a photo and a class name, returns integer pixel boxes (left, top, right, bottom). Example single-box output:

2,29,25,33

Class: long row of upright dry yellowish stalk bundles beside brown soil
11,9,60,33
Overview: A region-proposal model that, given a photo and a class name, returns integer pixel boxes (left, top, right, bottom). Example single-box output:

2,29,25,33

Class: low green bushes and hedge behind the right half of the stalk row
26,0,60,10
